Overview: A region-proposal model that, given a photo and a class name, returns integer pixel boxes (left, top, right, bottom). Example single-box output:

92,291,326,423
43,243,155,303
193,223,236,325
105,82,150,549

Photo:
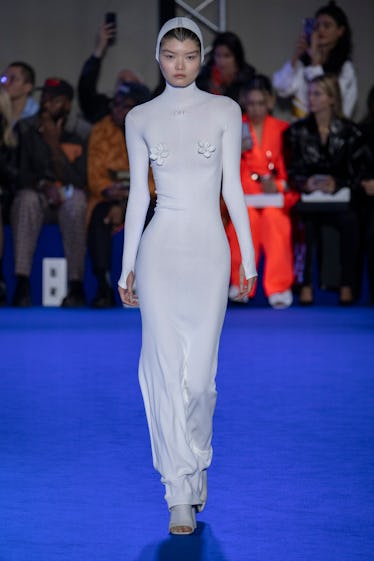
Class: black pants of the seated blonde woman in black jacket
301,209,359,289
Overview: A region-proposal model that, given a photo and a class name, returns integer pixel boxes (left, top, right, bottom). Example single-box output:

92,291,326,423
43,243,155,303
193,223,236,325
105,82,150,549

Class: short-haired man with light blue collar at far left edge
1,61,39,124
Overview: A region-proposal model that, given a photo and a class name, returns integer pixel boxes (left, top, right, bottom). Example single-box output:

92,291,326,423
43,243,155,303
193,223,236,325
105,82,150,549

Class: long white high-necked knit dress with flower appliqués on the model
119,83,256,509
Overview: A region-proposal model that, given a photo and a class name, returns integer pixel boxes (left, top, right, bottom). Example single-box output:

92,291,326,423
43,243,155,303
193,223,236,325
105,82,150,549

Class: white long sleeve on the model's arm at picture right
222,103,257,279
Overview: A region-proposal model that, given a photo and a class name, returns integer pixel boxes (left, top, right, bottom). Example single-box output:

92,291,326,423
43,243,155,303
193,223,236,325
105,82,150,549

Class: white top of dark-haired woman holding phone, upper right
273,60,358,118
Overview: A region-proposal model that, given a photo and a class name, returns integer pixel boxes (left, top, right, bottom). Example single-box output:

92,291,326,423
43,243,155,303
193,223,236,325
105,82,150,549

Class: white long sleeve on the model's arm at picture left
118,112,150,288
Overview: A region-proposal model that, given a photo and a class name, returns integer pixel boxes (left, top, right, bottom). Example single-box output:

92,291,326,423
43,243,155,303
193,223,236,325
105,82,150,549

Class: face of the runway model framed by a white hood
159,38,201,88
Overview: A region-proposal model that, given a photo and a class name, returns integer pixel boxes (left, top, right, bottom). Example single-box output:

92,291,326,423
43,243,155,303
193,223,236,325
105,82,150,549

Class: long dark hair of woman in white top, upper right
315,1,352,74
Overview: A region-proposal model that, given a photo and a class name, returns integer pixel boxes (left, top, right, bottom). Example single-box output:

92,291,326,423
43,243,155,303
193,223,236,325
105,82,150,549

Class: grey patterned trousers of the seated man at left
11,189,87,280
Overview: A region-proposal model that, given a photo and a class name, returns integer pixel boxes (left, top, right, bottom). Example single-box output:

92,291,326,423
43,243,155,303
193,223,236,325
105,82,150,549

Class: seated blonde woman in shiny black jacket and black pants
284,75,366,305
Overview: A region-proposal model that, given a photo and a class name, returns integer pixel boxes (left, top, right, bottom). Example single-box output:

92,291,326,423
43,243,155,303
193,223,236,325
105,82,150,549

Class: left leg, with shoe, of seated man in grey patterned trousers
11,189,47,307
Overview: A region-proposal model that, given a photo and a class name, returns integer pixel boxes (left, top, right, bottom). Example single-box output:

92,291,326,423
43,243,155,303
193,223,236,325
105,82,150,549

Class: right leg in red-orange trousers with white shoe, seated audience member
260,207,293,308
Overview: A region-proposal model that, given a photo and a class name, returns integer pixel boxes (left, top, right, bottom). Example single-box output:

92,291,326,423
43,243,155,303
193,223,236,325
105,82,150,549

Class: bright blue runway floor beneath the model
0,307,374,561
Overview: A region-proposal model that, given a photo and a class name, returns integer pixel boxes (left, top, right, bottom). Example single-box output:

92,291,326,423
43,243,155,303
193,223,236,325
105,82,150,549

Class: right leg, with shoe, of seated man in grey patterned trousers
58,189,87,307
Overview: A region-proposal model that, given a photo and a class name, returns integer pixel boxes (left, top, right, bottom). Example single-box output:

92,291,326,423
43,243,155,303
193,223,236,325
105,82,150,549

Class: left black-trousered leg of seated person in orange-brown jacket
87,202,115,308
